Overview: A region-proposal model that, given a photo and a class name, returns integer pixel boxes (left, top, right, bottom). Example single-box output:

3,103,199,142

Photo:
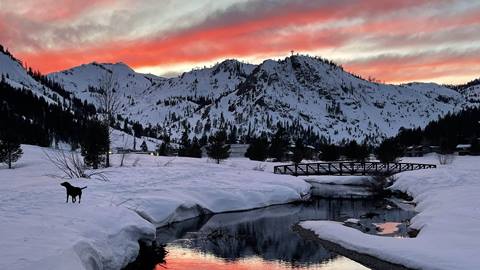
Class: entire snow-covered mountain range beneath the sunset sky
49,56,470,142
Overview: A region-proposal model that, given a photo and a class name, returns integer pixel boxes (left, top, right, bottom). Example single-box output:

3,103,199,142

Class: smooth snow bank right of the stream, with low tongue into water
301,156,480,269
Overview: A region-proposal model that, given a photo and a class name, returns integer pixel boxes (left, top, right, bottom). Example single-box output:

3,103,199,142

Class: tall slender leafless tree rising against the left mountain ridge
96,71,121,167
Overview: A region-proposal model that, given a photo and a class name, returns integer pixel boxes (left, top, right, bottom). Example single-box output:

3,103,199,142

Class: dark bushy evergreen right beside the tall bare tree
81,122,109,169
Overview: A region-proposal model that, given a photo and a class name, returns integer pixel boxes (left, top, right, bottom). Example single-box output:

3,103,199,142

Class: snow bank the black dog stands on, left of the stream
0,145,310,269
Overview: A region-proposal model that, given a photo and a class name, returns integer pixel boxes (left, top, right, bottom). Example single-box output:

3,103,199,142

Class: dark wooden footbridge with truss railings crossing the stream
273,161,437,176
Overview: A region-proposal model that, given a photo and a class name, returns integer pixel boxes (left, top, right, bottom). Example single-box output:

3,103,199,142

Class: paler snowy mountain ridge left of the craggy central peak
49,60,253,131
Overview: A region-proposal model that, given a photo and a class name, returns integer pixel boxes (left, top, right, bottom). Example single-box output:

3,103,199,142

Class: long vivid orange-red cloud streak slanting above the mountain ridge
15,1,434,72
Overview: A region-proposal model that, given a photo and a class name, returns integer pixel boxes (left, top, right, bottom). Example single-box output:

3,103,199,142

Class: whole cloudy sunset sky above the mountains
0,0,480,84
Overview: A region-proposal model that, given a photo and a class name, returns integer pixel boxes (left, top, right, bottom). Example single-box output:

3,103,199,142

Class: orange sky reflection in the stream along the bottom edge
155,244,368,270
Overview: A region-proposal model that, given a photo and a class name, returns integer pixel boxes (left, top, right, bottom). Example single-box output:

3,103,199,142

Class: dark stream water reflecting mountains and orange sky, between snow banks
127,196,415,270
